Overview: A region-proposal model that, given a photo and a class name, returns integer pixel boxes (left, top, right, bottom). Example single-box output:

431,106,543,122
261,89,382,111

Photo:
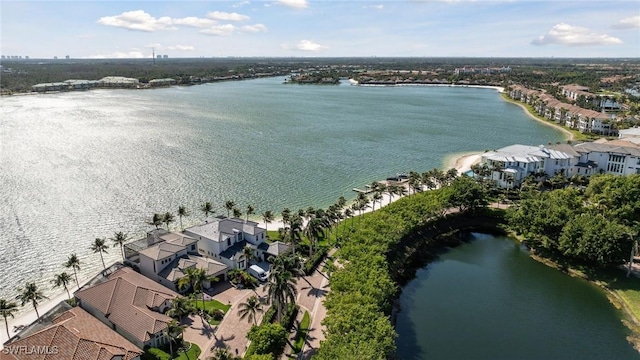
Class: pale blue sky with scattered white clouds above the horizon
0,0,640,59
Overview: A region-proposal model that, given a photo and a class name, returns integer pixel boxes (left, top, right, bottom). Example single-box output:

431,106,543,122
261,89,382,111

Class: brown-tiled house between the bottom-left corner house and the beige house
74,267,178,349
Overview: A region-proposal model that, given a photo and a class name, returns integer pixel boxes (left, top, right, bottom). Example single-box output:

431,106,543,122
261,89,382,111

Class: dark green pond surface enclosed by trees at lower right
397,234,640,360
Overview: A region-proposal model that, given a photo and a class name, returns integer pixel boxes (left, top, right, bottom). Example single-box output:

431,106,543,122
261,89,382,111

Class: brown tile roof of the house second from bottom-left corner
75,268,178,342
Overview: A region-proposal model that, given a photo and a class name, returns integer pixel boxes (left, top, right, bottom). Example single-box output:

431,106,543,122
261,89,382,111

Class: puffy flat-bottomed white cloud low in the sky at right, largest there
531,23,622,46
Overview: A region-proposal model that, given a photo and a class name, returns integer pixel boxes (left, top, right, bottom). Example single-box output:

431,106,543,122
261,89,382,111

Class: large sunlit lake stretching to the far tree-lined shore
0,78,563,298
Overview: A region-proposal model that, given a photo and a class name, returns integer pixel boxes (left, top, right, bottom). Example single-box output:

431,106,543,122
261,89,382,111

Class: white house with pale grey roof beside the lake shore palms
184,216,269,269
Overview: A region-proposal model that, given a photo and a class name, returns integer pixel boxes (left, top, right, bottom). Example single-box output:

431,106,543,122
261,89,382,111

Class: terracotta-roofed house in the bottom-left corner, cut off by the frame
0,302,142,360
